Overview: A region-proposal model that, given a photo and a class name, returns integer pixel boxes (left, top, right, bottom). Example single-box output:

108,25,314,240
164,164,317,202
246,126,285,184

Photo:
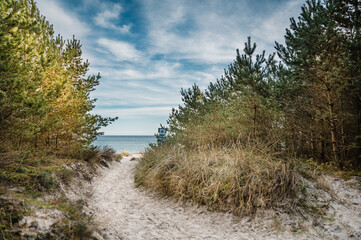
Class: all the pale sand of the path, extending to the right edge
88,155,361,240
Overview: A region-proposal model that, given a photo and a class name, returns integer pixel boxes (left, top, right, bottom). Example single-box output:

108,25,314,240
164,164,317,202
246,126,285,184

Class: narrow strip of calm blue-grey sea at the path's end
94,136,157,153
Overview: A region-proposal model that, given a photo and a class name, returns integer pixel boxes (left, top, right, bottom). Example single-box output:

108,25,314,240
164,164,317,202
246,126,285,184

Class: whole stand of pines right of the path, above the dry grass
164,0,361,168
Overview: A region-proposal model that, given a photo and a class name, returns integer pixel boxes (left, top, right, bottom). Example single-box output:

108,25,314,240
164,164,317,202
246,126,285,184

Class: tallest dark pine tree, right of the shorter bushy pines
276,0,354,167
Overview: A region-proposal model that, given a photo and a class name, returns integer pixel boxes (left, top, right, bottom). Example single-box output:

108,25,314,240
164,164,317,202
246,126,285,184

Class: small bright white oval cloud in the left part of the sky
97,38,142,62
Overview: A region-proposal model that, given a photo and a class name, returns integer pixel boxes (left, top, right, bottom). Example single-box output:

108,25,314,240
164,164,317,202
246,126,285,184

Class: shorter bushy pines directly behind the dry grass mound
168,38,282,148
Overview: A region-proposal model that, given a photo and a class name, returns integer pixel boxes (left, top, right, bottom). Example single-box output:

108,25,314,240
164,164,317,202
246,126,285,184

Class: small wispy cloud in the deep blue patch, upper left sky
94,4,131,33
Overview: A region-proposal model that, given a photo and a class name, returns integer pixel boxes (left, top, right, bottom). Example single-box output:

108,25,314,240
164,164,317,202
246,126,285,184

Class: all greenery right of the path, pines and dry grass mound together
135,0,361,217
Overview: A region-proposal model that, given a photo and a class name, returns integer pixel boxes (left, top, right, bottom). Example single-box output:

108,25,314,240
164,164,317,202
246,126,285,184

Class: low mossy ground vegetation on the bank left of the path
0,148,117,239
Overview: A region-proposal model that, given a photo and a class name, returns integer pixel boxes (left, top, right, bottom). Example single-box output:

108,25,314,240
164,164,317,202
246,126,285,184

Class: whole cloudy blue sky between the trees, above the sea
36,0,304,135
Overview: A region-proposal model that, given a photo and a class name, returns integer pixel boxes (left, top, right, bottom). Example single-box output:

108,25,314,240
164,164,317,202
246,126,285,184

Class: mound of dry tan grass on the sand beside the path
135,146,296,215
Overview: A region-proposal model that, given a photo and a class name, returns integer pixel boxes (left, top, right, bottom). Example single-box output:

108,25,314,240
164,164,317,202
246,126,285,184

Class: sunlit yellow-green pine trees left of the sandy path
0,0,115,152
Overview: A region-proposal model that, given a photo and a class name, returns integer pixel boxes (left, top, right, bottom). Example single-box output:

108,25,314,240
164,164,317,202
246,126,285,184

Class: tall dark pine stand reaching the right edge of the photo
276,0,361,168
